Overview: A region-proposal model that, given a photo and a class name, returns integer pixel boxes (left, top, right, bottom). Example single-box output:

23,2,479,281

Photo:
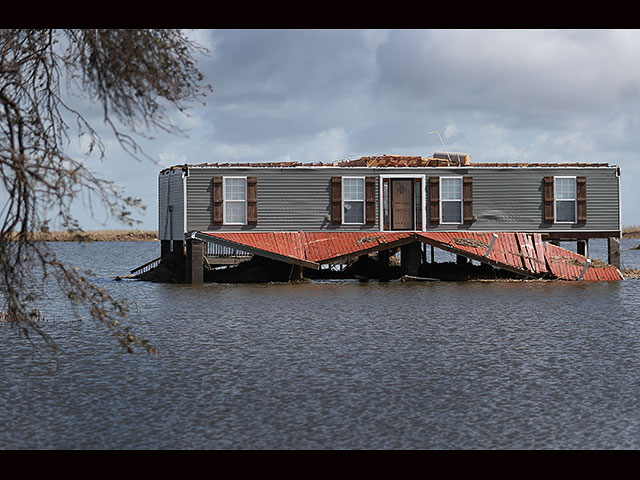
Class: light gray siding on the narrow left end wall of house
158,170,185,240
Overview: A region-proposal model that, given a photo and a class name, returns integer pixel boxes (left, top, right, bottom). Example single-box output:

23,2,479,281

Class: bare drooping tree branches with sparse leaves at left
0,29,214,352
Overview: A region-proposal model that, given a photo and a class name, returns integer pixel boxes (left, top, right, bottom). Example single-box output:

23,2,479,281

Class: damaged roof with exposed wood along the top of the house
161,152,609,173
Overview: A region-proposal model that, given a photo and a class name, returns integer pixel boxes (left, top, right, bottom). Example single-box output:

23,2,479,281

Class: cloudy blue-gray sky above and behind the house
70,29,640,229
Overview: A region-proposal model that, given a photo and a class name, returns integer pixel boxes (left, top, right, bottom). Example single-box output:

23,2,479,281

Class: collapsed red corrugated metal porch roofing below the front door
199,232,623,281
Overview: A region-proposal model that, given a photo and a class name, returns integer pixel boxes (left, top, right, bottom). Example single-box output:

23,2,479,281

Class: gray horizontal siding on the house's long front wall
181,166,620,232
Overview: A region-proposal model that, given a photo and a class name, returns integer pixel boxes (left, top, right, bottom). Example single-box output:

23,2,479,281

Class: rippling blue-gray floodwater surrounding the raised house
0,240,640,449
